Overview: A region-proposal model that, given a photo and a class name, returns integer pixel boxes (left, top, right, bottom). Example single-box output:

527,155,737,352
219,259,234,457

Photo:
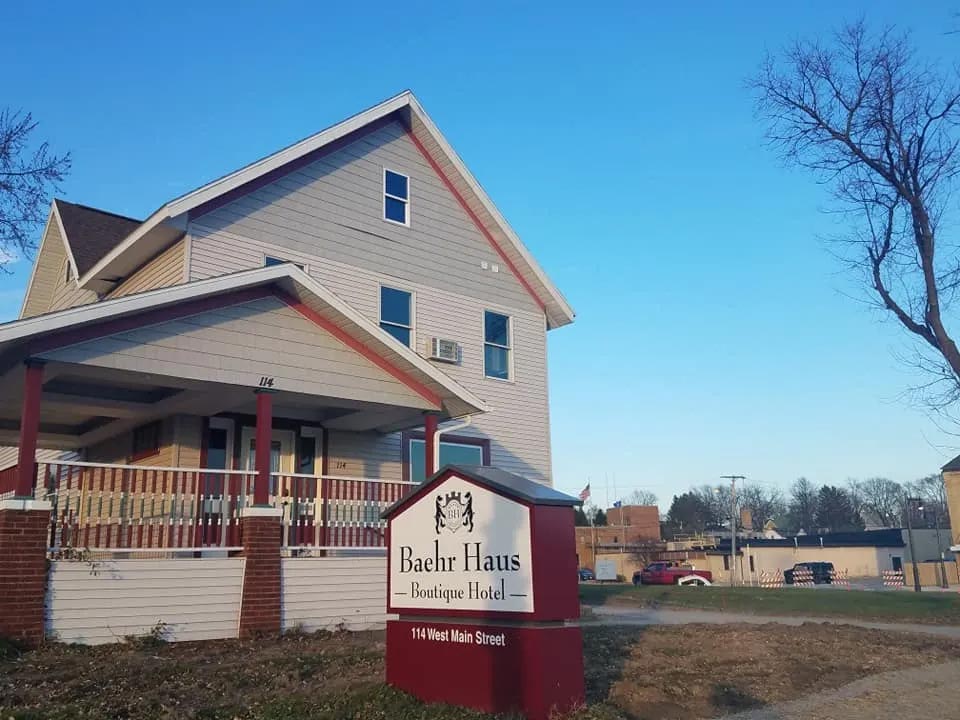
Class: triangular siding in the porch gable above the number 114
37,298,431,409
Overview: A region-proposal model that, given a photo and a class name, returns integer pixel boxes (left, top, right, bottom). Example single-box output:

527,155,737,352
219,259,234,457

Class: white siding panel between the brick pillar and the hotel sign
280,557,387,631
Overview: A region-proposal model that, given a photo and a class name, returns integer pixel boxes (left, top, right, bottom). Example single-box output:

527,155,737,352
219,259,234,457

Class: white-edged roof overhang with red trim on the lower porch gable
0,263,489,417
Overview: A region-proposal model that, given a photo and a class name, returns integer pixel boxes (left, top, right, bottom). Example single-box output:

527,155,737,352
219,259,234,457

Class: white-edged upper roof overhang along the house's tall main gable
80,91,574,327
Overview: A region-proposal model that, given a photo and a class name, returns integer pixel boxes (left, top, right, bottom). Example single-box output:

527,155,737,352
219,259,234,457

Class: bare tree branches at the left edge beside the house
0,110,71,269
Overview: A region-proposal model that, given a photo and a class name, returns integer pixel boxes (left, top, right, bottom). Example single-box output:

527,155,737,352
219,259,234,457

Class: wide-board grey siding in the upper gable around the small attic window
191,123,539,310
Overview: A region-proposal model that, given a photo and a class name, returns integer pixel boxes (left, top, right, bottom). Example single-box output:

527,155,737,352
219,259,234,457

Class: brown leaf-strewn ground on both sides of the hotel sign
0,624,960,720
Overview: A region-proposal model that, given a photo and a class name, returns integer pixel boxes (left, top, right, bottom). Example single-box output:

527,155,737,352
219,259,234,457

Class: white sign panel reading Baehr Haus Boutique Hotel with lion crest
390,475,533,612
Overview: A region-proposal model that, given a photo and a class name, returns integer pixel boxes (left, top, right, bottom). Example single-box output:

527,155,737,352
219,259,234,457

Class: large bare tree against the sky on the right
752,23,960,412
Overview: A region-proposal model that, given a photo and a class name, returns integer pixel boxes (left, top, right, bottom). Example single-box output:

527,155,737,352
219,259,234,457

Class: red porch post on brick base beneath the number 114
239,390,283,638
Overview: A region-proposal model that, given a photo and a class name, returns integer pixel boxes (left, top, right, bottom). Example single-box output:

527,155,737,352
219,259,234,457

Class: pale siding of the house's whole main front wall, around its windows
188,125,551,481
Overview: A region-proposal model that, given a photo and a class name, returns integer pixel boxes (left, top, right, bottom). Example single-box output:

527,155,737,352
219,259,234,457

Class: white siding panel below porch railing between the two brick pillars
46,558,244,645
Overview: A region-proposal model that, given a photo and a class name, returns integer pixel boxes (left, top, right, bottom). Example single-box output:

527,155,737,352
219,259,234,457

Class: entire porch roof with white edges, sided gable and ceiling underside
0,264,487,447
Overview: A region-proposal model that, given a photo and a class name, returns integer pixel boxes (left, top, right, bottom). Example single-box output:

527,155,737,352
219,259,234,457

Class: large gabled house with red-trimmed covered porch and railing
0,92,574,547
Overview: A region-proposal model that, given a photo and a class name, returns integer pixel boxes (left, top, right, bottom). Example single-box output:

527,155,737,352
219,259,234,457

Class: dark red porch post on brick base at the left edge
0,361,51,647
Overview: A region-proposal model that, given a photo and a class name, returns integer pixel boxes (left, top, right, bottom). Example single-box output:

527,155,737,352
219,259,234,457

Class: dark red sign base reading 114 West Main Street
387,619,584,720
